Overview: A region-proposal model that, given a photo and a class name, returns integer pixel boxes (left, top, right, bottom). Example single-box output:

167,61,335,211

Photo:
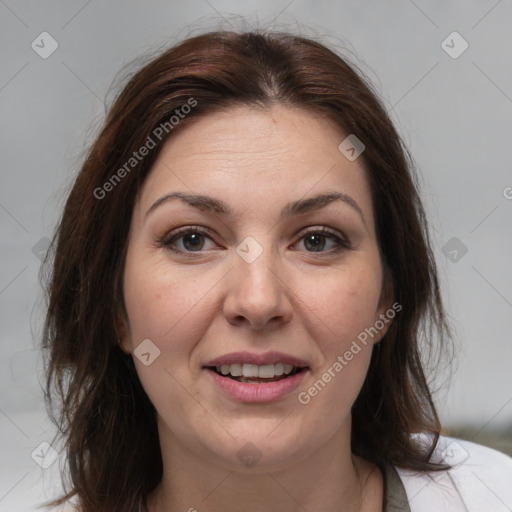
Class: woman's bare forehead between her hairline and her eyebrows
139,106,372,228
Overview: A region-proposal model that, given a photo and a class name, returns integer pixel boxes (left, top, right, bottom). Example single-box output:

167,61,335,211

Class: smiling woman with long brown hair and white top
44,32,512,512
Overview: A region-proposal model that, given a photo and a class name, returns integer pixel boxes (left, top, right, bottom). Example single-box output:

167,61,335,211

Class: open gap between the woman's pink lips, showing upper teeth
205,363,308,384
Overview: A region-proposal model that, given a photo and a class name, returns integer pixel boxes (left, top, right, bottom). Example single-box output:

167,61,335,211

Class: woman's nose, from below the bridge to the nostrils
223,252,293,331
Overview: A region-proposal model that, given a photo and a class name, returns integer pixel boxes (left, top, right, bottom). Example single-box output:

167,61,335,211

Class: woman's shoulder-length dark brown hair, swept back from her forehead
43,31,447,512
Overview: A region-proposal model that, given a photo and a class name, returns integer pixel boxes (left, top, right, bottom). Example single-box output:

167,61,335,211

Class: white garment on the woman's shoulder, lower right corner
396,434,512,512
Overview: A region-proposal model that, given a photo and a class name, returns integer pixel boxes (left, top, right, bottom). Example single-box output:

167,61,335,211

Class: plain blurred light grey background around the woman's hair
0,0,512,512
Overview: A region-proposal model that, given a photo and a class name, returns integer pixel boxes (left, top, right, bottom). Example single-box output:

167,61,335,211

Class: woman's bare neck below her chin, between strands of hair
148,420,383,512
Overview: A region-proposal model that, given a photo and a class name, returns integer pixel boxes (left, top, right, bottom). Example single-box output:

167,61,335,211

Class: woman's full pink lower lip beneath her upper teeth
206,368,307,402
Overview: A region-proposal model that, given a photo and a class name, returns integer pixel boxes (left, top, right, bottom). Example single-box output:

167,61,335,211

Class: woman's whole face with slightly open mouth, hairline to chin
121,107,389,469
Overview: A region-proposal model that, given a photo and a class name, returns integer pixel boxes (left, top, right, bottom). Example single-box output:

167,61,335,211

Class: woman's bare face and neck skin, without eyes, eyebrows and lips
121,106,392,512
